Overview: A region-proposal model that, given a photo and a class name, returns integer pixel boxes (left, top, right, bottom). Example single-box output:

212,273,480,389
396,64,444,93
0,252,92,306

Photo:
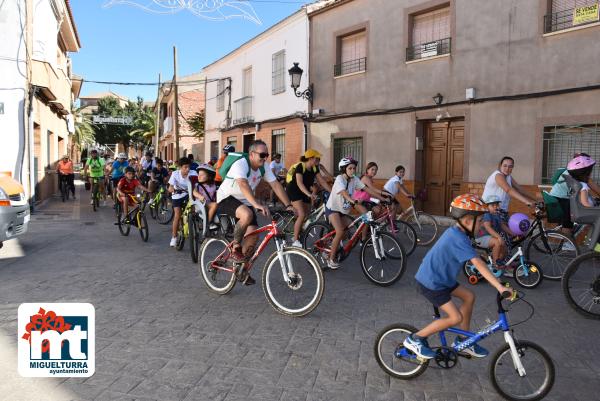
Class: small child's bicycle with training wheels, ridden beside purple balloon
463,245,544,288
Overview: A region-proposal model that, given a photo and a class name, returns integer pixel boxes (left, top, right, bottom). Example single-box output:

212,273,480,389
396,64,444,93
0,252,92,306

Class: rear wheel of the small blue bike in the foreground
373,323,429,379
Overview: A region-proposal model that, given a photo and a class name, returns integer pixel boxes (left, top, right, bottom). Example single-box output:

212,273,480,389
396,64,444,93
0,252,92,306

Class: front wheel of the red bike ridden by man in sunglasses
262,248,324,316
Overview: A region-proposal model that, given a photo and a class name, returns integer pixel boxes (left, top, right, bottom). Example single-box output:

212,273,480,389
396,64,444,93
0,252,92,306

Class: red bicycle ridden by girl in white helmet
302,212,406,286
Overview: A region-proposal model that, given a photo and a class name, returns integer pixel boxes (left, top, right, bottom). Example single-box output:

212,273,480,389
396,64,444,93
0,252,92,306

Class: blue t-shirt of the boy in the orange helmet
415,226,477,291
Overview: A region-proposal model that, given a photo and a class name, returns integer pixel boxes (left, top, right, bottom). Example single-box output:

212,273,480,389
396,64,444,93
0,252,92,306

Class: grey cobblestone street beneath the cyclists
0,187,600,401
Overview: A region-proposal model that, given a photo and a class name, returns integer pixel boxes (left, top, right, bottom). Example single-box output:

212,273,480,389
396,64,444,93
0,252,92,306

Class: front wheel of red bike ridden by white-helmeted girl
360,232,406,287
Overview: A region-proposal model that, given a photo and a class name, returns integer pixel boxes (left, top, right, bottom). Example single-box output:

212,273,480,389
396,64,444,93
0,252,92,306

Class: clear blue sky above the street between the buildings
70,0,309,101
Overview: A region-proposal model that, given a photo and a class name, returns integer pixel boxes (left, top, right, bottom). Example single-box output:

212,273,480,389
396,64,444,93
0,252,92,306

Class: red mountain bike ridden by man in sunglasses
200,209,324,316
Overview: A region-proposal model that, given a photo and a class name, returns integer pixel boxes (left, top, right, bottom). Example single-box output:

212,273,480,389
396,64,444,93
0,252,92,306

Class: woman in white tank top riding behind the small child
483,156,535,219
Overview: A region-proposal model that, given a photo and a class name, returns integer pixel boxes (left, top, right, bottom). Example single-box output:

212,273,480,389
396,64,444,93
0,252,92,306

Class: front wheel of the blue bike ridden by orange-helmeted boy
489,341,554,401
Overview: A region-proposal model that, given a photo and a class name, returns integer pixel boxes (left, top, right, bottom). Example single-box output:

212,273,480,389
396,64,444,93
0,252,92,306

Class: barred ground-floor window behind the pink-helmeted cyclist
542,122,600,184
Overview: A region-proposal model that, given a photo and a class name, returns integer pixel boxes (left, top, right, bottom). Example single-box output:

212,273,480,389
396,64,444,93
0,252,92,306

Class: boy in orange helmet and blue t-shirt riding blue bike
403,194,512,359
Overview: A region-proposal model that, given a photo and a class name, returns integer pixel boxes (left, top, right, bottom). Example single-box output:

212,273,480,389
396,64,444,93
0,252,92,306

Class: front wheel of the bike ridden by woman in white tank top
525,231,579,280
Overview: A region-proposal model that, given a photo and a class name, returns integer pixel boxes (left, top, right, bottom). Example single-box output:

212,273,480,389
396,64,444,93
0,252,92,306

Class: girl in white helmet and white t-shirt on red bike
325,157,384,270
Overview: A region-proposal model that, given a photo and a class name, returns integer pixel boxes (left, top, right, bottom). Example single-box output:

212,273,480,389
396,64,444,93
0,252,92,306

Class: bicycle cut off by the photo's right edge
561,176,600,319
